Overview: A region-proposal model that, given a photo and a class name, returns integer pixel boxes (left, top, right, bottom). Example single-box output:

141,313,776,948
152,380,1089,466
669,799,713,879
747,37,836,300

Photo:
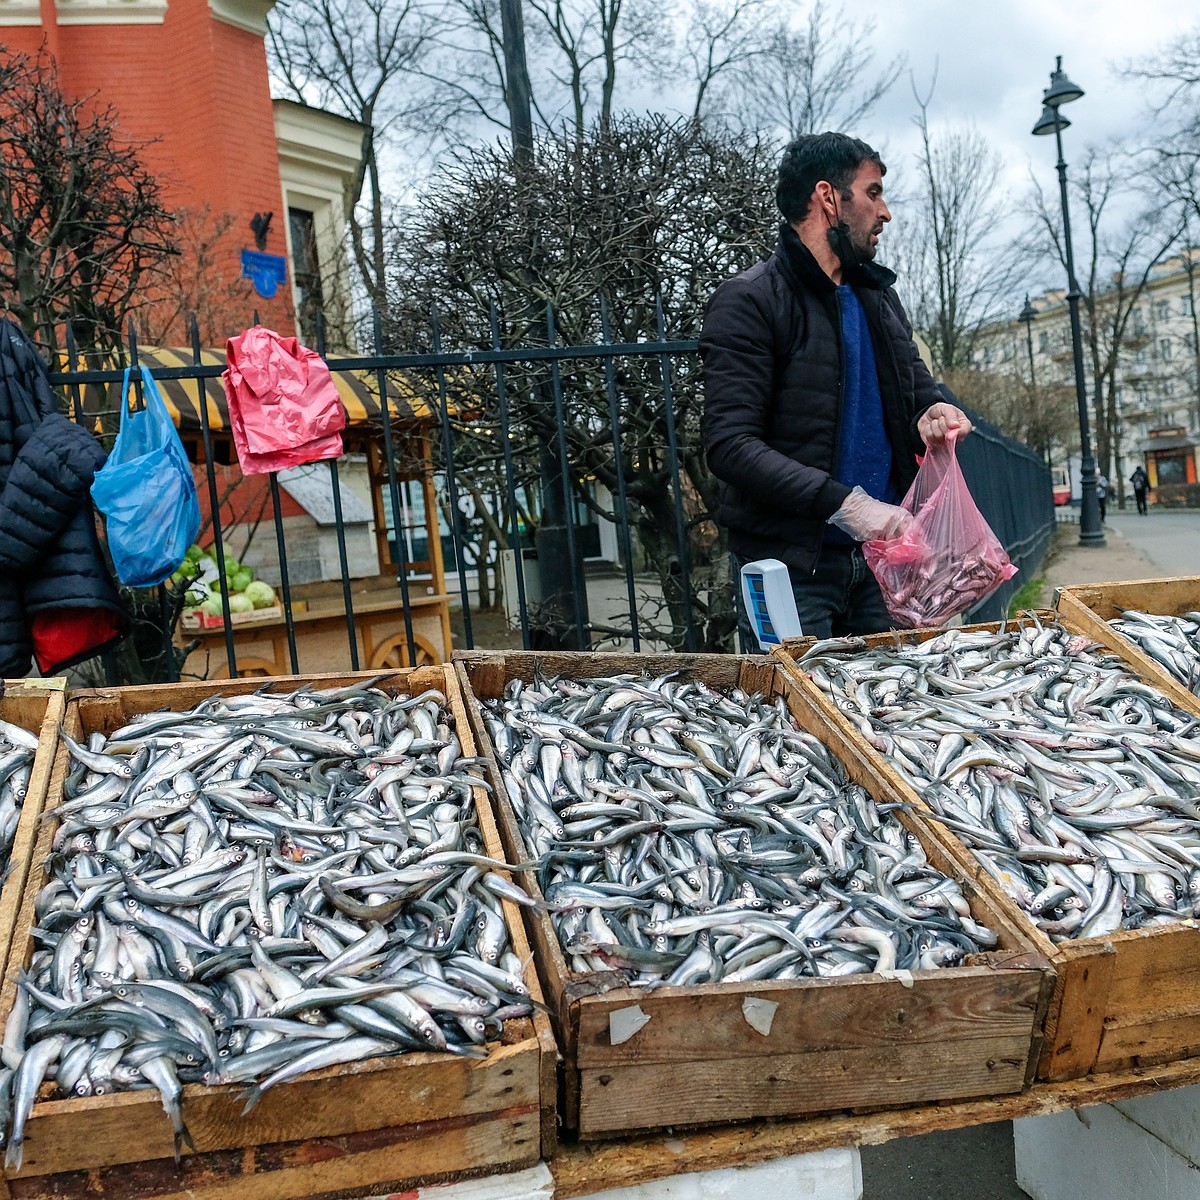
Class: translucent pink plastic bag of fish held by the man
863,431,1016,629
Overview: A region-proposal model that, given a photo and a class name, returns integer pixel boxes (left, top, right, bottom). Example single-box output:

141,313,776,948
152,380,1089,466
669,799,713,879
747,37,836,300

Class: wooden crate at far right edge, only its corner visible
1056,575,1200,715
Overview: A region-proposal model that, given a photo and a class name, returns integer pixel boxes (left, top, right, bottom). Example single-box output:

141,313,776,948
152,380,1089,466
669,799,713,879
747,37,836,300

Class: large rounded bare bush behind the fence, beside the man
389,116,776,649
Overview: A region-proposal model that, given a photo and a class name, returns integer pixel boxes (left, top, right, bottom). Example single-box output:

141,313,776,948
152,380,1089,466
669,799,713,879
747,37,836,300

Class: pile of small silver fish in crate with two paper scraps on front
484,674,996,986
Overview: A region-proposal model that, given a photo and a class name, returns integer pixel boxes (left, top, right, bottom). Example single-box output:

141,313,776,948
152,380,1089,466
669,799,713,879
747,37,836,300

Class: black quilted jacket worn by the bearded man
700,224,942,570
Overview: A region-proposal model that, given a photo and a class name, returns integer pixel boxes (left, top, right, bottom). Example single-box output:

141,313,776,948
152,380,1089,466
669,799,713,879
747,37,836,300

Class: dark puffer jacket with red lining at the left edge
0,322,126,678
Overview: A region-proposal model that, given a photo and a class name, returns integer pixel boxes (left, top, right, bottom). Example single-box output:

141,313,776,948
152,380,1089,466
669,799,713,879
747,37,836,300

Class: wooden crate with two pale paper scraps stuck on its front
455,653,1052,1139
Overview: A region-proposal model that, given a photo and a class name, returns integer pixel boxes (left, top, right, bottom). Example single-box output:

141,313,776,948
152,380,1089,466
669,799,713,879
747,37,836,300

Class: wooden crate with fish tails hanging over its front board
0,666,554,1200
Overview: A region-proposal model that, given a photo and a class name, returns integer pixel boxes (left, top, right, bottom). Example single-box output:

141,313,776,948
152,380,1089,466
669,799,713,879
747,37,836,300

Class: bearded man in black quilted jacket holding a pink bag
700,133,971,646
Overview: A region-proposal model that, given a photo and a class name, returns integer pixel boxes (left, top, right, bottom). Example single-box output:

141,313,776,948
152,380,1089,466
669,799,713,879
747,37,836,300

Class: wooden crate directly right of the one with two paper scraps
774,613,1200,1081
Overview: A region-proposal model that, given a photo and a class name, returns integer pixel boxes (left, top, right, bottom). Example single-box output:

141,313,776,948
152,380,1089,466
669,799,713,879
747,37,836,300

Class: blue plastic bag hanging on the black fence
91,367,200,588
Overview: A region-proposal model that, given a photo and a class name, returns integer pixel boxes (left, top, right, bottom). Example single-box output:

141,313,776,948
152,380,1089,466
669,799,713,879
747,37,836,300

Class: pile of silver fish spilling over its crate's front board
0,680,529,1166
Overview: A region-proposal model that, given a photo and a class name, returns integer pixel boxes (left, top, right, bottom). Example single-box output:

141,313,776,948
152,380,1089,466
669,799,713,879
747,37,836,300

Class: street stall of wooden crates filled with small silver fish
7,581,1200,1200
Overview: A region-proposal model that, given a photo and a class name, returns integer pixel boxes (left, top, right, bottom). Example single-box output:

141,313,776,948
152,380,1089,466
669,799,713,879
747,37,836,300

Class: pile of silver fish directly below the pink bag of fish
800,619,1200,941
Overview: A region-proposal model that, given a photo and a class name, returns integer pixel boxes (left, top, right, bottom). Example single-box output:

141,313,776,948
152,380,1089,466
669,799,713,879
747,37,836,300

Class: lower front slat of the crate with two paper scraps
580,1037,1027,1138
